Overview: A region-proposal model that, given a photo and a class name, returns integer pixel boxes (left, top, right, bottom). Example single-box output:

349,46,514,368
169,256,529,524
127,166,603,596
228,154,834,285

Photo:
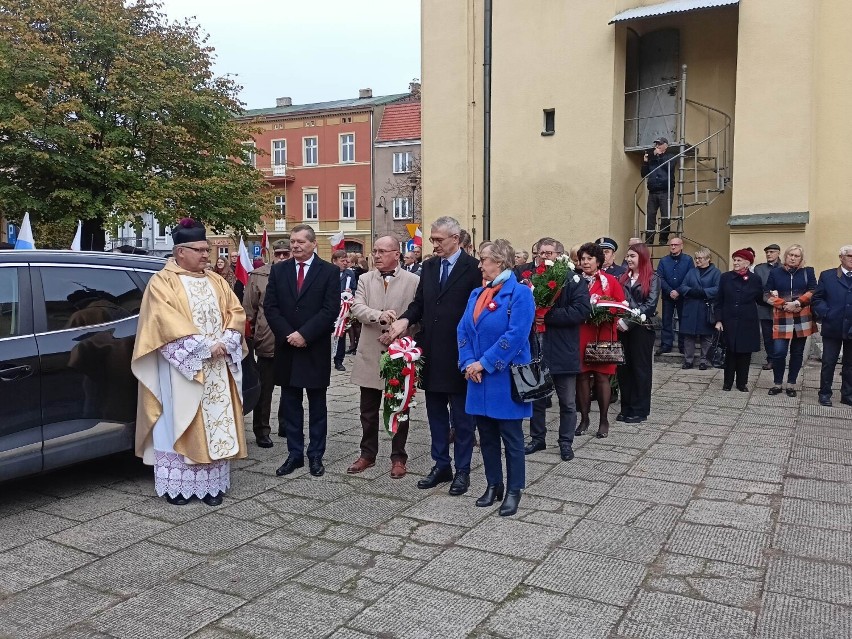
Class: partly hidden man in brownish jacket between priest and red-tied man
243,240,290,448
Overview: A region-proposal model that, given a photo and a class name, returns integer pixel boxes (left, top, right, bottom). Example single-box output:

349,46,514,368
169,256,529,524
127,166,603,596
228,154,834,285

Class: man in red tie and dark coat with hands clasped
263,224,340,477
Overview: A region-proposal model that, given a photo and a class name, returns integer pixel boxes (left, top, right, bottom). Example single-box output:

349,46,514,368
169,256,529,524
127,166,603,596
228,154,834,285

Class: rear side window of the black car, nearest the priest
41,266,142,331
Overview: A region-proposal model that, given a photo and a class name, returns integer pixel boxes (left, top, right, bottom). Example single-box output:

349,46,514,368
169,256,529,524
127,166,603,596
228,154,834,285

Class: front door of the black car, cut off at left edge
0,264,42,481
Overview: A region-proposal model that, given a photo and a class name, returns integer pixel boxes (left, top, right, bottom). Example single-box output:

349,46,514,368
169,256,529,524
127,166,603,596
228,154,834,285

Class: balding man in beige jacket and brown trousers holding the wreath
346,235,420,479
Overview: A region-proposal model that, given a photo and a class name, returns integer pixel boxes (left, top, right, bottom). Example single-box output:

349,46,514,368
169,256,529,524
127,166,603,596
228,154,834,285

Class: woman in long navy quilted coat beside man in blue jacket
677,248,722,370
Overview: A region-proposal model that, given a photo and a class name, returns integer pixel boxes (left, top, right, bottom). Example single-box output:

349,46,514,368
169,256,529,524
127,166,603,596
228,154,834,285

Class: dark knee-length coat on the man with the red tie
263,257,340,388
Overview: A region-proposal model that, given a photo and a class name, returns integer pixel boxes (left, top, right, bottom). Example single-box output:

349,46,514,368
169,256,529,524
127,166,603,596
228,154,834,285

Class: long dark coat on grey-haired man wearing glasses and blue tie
400,251,482,393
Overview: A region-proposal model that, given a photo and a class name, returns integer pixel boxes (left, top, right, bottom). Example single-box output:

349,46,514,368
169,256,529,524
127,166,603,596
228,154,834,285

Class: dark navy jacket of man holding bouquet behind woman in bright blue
539,273,592,375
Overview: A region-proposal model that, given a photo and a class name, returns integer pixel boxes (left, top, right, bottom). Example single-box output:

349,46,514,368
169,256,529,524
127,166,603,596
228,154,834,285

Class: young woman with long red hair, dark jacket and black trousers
615,243,660,424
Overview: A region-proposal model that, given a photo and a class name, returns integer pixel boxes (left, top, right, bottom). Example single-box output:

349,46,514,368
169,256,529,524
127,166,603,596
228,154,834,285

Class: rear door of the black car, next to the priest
32,264,142,470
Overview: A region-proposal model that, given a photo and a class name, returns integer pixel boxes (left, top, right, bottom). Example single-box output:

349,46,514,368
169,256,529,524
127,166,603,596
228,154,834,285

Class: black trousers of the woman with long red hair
616,326,655,417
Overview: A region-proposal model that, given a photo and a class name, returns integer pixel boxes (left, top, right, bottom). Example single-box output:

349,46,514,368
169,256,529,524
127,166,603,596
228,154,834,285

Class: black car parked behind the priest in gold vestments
0,251,260,481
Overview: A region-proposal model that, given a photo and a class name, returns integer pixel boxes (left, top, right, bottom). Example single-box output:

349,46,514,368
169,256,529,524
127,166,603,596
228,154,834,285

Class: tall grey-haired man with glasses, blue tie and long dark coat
390,216,482,495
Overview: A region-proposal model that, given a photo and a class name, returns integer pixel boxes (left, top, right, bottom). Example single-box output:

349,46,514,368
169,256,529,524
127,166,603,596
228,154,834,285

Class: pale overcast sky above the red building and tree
163,0,420,109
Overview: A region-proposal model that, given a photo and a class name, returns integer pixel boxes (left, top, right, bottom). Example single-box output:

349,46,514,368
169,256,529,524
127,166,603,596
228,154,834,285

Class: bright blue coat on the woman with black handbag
458,274,535,419
